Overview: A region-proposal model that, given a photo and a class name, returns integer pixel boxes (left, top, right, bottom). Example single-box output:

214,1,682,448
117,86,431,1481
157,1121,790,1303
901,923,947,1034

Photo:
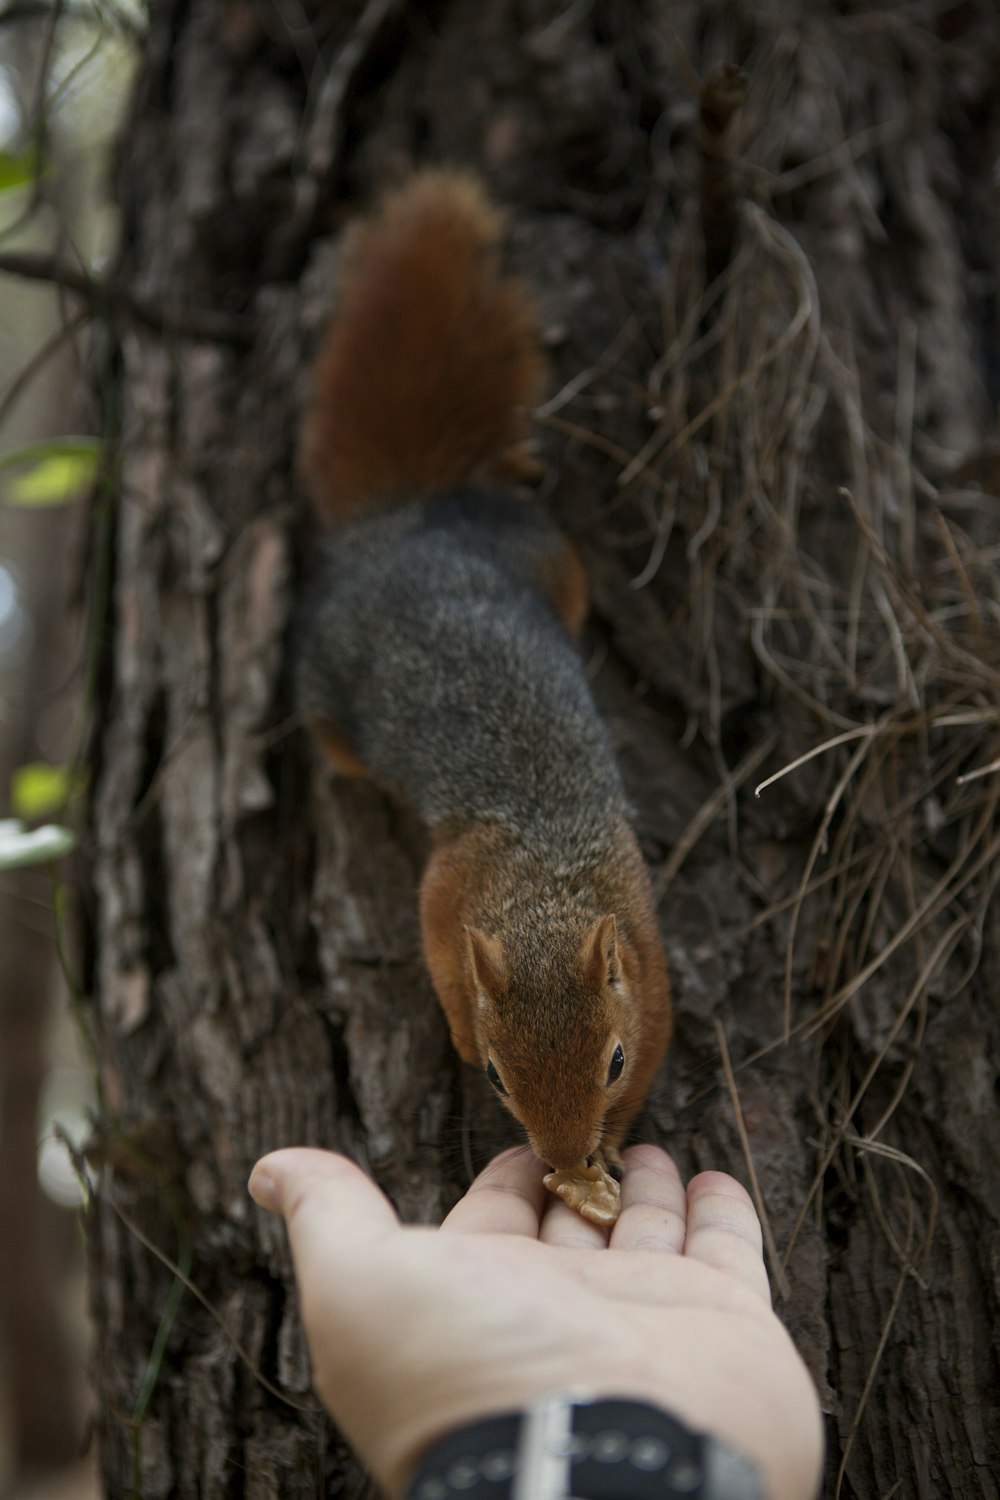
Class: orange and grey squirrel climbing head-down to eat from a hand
295,170,670,1217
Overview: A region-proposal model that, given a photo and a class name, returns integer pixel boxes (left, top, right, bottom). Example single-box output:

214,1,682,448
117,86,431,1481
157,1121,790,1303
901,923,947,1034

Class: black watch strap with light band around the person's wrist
406,1391,765,1500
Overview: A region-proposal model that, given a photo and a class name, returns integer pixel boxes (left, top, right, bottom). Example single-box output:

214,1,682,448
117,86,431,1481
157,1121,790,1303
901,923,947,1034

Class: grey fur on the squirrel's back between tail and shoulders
295,495,627,867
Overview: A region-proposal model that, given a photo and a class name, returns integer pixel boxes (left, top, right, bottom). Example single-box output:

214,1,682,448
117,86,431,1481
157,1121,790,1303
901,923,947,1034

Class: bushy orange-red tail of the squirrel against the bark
301,170,544,522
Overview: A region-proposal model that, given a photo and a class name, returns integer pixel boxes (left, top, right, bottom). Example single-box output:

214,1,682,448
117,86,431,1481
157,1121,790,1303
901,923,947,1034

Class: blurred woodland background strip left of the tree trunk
0,0,144,1500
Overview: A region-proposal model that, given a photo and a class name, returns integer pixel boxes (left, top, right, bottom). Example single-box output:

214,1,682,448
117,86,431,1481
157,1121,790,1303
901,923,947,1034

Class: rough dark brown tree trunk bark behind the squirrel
84,0,1000,1500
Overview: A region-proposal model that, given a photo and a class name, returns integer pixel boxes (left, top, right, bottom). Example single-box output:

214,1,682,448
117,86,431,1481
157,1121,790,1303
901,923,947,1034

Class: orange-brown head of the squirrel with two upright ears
466,915,639,1170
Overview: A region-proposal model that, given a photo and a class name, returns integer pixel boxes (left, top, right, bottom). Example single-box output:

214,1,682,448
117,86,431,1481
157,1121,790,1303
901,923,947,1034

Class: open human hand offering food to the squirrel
250,1146,822,1500
